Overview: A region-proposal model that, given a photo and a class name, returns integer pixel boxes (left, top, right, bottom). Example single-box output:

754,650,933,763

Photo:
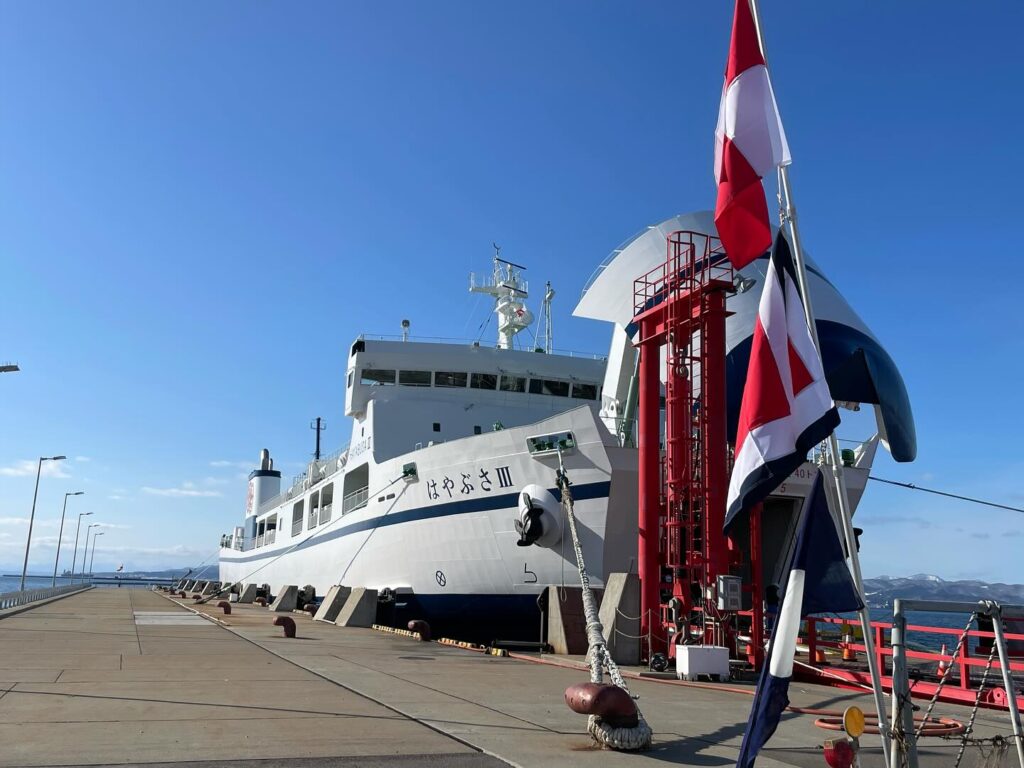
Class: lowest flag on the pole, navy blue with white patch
736,470,864,768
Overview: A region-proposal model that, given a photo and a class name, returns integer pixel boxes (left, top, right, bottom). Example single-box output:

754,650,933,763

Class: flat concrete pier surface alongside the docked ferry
0,589,1015,768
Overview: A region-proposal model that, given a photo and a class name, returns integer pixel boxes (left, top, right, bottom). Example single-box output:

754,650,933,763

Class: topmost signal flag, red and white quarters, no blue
715,0,791,269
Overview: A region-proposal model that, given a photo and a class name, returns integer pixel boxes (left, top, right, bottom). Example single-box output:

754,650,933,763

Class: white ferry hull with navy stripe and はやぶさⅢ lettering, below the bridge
220,406,637,627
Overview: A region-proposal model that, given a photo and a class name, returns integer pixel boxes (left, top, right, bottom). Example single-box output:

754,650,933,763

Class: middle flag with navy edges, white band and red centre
725,230,840,528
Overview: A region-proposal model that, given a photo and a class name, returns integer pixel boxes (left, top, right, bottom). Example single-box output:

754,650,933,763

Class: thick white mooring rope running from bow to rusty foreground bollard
557,452,652,752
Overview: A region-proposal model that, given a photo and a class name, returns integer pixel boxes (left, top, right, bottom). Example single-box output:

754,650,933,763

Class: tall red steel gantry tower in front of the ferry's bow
634,231,762,657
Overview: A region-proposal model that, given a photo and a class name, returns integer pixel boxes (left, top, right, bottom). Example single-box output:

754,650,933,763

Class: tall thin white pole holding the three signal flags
749,0,892,765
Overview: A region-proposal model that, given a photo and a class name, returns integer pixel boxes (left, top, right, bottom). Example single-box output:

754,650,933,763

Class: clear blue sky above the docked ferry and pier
0,0,1024,582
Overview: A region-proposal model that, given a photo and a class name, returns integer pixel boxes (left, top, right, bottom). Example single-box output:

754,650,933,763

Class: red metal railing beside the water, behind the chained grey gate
801,616,1024,709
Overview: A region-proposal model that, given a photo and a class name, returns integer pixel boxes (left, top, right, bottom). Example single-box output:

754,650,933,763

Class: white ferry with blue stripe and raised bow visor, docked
219,212,915,637
